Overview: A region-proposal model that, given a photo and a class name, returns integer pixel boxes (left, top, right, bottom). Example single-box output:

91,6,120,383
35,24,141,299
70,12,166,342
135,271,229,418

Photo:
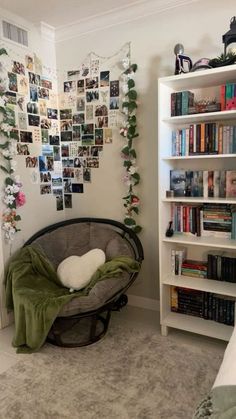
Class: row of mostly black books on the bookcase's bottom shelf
171,286,235,326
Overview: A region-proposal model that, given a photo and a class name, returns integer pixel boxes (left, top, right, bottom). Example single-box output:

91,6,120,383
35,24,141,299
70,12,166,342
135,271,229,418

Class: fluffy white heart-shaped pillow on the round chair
57,249,106,291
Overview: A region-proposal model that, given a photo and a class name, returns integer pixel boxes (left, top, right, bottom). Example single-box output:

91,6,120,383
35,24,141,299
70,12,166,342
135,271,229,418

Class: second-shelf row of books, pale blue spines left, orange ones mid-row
171,122,236,156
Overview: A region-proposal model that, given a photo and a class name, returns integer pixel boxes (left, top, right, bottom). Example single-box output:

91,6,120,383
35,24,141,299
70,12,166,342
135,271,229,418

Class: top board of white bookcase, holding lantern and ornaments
159,64,236,91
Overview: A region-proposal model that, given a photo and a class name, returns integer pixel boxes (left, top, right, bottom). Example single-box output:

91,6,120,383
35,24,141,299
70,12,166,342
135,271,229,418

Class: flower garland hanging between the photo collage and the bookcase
120,57,142,233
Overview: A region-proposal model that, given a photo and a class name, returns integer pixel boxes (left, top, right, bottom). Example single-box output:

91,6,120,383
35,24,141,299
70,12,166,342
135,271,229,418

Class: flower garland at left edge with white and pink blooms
0,48,25,240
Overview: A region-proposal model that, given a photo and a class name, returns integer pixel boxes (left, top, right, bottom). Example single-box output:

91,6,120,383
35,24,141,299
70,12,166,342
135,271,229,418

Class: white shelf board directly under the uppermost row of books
162,110,236,124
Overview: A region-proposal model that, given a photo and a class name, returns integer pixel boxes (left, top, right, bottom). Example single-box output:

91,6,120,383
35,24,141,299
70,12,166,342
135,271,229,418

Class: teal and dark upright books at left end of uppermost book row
171,90,194,116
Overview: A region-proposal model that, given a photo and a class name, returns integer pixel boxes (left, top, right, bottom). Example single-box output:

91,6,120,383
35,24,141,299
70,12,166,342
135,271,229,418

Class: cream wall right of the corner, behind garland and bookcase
56,0,236,299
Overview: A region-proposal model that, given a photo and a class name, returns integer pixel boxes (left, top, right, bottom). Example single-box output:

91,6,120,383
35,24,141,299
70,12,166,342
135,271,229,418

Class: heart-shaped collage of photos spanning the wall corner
5,54,120,211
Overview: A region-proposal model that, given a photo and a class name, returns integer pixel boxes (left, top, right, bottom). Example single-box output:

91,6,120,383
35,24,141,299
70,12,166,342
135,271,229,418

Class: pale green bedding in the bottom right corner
192,385,236,419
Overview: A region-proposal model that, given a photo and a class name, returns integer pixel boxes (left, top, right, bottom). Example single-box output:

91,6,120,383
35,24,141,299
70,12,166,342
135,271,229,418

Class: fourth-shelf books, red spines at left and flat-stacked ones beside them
171,203,235,239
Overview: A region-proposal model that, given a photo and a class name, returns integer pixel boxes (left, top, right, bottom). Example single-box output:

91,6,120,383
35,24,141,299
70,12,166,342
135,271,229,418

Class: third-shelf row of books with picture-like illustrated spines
170,169,236,198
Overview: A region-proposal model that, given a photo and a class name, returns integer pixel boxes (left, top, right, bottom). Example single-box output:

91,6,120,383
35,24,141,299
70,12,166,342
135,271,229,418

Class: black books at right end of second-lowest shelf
207,252,236,283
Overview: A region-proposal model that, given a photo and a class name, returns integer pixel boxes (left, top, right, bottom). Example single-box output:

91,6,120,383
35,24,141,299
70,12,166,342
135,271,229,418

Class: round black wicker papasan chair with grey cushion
24,218,143,347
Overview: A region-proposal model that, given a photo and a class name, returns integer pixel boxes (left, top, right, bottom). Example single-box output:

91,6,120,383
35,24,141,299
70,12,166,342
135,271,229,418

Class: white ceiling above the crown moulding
0,0,154,29
